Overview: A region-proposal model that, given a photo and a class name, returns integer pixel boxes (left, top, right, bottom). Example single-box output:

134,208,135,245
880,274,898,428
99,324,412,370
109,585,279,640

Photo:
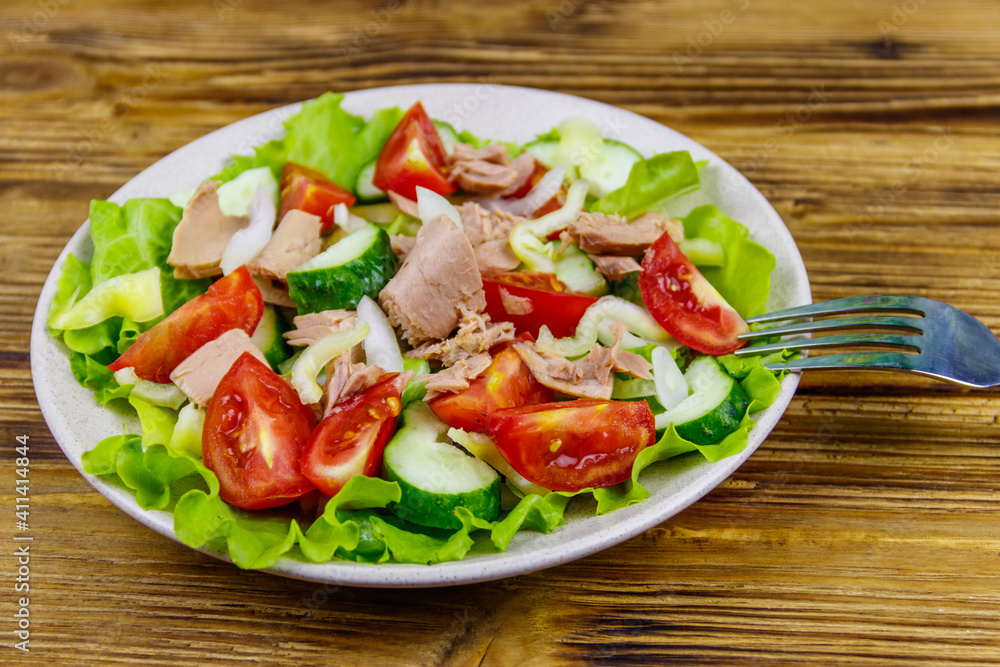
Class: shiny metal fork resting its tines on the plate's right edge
736,295,1000,388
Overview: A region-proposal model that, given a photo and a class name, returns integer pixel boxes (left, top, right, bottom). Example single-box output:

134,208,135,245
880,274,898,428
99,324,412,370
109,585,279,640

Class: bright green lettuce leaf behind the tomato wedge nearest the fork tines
683,206,775,318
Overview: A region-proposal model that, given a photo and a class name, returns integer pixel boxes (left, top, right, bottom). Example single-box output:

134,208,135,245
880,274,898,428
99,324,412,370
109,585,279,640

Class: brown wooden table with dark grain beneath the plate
0,0,1000,665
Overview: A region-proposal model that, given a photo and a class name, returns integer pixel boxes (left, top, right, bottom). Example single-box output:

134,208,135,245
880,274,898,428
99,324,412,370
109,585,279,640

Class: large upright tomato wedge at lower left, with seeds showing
201,352,315,510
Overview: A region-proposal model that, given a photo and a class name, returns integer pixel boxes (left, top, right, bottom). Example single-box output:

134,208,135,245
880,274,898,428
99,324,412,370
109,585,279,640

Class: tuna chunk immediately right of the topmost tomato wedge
449,143,535,197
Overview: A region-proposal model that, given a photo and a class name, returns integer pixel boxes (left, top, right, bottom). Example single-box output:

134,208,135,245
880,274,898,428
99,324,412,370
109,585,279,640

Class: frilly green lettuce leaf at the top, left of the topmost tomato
212,93,403,191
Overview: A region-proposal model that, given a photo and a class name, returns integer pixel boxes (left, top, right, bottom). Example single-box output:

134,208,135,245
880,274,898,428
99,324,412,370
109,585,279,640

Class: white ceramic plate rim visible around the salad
31,84,811,587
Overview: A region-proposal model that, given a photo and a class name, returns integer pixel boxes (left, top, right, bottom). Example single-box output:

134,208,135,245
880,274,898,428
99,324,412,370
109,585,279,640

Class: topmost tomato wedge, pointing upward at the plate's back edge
372,102,456,200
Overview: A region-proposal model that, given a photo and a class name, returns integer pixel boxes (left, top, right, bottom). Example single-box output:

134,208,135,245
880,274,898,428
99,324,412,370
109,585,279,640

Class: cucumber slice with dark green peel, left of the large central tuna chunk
286,224,397,315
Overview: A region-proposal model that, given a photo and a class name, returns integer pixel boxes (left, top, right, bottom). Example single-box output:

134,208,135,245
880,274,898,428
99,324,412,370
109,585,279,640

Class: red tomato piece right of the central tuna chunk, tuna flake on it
483,272,597,338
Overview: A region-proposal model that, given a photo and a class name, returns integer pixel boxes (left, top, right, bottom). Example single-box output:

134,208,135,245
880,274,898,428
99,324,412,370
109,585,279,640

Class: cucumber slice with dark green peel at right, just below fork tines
656,357,750,445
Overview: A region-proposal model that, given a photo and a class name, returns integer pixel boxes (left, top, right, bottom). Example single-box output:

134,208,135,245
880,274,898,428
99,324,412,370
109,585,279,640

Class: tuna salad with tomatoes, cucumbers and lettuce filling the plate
48,93,779,568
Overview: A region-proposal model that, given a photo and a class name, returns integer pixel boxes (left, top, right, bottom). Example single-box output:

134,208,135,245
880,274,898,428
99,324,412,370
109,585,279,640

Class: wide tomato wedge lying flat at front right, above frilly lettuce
490,399,656,491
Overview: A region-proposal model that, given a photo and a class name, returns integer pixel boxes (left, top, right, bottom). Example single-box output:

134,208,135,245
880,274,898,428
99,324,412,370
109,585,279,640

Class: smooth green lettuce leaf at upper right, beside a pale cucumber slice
590,151,700,218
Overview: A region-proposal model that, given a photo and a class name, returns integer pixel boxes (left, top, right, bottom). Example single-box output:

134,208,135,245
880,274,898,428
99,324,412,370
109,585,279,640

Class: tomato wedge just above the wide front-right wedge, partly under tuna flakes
427,343,553,433
